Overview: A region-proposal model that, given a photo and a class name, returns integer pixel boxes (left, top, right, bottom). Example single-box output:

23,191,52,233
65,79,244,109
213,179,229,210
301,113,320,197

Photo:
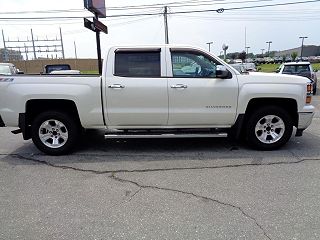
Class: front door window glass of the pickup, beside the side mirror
171,51,218,78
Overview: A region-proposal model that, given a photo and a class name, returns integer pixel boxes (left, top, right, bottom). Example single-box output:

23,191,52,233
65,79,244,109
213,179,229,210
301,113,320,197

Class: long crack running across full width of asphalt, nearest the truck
4,154,320,174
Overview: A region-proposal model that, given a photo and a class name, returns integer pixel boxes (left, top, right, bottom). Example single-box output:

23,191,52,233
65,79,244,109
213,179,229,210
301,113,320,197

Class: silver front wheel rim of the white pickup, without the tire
255,115,286,144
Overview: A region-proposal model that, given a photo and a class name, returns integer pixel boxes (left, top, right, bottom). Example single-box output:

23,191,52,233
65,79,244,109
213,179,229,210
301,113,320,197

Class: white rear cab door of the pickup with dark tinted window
106,48,168,128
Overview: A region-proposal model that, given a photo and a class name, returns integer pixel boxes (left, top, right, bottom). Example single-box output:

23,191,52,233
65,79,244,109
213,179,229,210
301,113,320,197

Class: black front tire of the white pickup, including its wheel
246,106,293,151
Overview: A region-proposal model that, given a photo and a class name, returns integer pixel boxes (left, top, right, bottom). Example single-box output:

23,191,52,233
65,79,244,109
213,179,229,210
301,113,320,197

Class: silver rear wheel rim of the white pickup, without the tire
39,119,69,148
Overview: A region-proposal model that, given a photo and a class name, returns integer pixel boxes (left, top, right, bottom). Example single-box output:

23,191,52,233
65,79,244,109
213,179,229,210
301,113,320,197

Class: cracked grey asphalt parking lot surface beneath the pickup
0,96,320,240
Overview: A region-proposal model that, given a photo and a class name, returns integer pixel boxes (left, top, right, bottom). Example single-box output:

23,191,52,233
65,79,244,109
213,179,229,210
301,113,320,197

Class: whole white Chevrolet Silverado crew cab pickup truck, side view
0,45,314,155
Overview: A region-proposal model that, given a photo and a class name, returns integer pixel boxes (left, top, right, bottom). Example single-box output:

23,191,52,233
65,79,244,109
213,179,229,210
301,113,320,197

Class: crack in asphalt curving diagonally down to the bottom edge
109,174,271,240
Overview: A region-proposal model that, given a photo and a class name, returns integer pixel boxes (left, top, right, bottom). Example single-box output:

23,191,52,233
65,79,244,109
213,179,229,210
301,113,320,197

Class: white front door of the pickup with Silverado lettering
167,49,238,127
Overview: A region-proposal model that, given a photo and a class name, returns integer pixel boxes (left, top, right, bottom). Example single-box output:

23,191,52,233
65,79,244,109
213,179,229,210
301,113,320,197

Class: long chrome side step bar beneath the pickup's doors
104,133,228,139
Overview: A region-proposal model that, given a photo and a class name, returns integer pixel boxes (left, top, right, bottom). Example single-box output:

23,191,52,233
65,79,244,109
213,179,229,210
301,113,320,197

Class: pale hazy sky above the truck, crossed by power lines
0,0,320,59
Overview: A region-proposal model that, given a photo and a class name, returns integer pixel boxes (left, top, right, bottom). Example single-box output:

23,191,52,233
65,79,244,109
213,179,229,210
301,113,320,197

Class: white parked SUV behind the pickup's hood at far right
277,62,318,94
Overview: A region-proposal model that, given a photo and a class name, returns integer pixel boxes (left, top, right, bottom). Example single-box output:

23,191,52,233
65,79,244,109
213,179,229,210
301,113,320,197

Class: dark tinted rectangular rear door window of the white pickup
114,50,161,77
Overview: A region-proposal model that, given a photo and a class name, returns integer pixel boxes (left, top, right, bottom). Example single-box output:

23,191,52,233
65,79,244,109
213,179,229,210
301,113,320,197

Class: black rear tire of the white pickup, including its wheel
31,111,81,155
